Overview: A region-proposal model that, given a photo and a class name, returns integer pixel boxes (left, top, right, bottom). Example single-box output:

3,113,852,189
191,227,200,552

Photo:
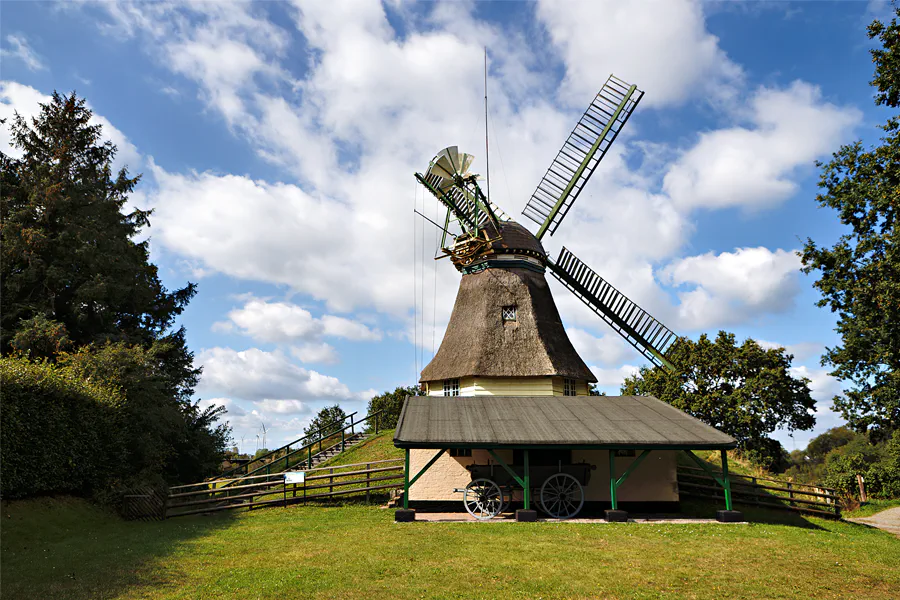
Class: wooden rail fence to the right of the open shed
678,466,841,518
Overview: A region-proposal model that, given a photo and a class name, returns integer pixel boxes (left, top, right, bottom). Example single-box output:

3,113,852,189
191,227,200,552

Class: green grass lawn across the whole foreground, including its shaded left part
0,499,900,600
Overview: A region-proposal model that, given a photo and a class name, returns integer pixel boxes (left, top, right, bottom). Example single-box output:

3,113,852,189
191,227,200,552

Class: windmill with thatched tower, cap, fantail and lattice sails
415,75,678,382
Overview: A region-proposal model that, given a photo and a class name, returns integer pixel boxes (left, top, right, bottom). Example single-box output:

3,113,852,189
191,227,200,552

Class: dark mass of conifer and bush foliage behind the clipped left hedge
0,92,229,490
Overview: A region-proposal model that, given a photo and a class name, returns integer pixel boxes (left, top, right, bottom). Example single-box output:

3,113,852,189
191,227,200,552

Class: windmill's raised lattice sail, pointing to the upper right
522,75,644,239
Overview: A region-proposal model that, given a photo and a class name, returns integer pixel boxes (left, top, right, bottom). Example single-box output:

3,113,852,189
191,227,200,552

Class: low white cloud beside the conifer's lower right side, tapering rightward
197,348,354,402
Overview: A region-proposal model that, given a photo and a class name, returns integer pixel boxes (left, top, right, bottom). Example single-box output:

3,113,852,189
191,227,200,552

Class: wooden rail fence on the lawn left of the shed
165,458,403,518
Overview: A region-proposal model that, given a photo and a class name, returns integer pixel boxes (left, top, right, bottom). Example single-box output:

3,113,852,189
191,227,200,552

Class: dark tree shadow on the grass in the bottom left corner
0,498,234,600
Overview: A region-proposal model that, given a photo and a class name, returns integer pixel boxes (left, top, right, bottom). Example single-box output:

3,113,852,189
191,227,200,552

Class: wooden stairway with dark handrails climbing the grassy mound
220,411,383,477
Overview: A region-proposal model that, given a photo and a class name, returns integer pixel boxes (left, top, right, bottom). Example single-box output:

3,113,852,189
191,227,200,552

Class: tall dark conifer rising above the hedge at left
0,92,196,353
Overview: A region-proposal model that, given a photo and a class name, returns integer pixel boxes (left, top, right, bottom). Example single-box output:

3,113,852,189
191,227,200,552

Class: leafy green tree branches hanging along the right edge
801,4,900,437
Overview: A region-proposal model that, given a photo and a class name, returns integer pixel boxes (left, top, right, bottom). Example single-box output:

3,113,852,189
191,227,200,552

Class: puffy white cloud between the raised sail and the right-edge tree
663,81,862,209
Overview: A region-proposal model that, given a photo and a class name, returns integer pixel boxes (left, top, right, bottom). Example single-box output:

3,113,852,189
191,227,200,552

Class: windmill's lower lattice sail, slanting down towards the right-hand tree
548,247,678,369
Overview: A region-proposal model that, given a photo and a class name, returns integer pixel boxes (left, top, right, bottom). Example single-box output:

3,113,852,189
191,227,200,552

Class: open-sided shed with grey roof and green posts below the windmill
394,396,736,520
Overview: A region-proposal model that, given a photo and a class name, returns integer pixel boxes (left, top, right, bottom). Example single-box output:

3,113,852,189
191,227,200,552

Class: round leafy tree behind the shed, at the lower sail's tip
621,331,815,467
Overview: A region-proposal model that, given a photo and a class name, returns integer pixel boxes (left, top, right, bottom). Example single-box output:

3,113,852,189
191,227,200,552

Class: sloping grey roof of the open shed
394,396,736,450
